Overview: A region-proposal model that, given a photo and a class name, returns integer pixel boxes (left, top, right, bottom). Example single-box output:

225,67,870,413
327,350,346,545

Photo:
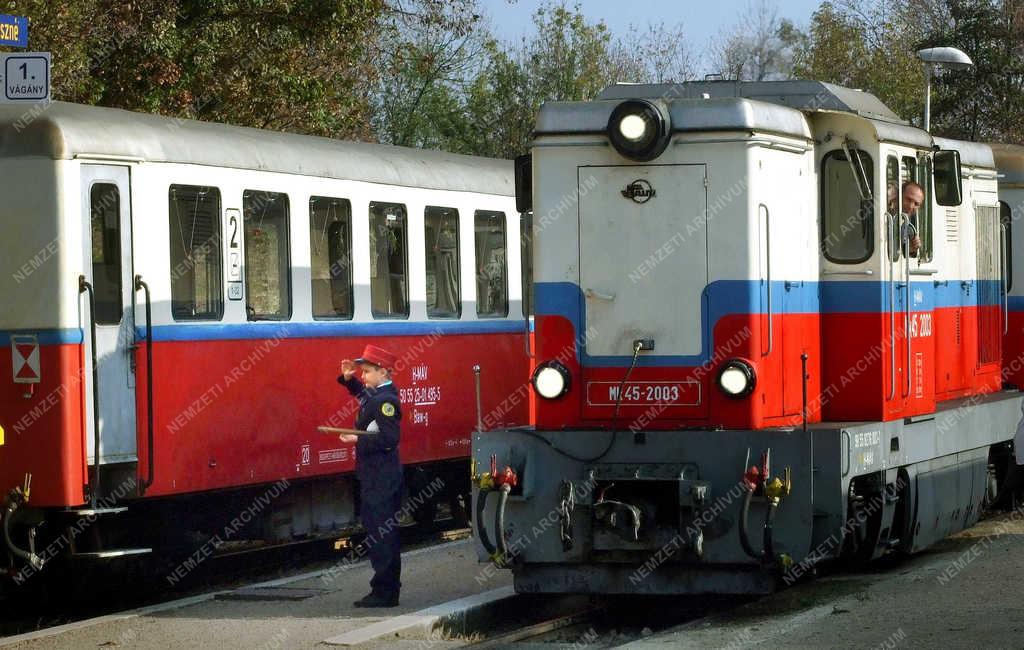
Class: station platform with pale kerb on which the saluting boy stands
0,539,512,650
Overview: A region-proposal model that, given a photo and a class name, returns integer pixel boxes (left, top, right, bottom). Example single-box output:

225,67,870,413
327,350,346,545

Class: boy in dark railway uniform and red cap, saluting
338,345,402,607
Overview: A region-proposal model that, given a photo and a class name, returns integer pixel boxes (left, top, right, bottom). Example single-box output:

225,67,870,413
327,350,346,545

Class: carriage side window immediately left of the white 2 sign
168,185,224,320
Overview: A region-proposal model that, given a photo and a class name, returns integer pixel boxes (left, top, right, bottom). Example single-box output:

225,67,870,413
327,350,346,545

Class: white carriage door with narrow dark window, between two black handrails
79,165,137,474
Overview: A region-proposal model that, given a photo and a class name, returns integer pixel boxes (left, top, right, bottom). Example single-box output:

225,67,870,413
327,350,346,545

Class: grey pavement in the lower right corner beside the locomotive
622,510,1024,650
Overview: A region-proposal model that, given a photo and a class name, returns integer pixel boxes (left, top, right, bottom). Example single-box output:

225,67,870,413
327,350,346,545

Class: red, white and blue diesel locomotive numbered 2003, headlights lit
473,82,1024,594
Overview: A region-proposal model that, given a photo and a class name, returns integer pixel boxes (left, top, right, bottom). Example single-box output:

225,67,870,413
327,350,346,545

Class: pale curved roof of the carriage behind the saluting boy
0,101,514,196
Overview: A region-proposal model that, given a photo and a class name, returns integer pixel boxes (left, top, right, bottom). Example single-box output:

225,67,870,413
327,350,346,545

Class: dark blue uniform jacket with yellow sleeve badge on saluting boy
338,377,402,501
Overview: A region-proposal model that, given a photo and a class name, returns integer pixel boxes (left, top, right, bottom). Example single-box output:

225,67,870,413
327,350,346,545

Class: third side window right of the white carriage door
309,197,352,318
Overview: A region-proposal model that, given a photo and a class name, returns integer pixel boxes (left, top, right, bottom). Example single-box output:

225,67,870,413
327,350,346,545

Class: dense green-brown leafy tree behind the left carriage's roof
0,0,472,139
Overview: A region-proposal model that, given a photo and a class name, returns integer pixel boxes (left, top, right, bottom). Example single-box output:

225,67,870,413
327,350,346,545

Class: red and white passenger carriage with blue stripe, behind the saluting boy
0,102,528,581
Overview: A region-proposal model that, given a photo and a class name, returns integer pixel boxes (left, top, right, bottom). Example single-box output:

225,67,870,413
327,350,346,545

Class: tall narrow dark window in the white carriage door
89,183,124,324
